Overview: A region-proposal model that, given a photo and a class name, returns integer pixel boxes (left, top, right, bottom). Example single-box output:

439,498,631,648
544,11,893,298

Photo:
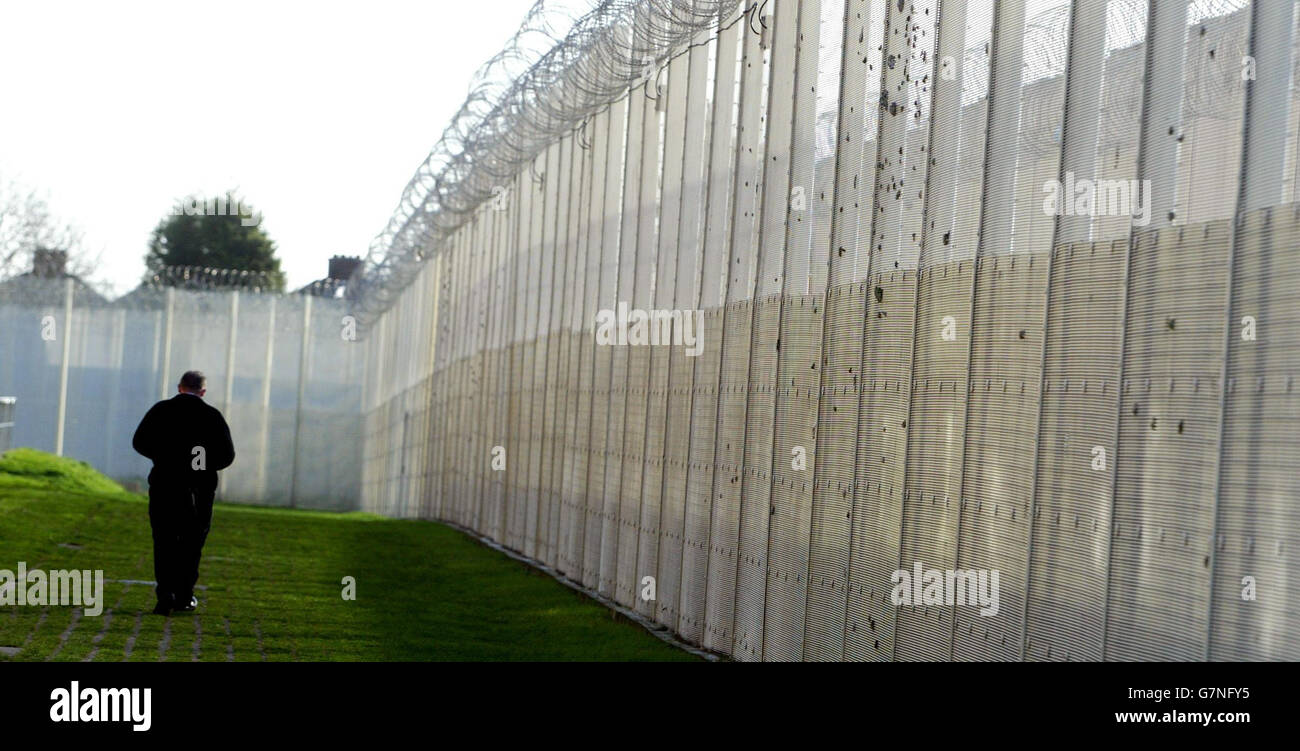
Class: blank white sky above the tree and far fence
0,0,543,294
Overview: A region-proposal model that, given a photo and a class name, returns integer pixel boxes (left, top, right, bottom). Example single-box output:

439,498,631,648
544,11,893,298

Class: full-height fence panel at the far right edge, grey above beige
1206,3,1300,660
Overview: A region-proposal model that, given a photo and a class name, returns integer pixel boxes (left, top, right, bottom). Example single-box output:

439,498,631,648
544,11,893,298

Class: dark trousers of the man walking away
150,482,215,607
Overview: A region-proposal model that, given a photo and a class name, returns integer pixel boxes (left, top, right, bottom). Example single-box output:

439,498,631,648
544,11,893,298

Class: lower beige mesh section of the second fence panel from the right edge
1105,222,1230,660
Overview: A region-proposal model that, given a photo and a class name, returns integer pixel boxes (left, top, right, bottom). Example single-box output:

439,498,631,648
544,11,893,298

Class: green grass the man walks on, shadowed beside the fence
0,448,696,661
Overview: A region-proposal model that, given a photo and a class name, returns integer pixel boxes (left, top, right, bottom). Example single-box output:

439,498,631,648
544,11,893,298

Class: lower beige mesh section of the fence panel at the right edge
1209,205,1300,660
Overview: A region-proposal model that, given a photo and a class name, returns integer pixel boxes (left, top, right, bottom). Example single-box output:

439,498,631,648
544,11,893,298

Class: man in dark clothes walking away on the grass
131,370,235,616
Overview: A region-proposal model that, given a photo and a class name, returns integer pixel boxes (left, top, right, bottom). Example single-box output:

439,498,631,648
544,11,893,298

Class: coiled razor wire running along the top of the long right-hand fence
348,0,748,327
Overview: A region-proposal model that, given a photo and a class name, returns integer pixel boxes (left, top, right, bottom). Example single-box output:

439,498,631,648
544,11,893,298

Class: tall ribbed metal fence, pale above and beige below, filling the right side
363,0,1300,660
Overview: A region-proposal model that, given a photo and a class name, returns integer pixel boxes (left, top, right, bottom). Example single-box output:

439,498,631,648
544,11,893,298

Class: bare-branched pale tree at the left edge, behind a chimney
0,171,99,282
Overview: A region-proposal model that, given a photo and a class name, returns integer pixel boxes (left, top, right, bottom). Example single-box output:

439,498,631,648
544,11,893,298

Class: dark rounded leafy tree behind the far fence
144,192,285,292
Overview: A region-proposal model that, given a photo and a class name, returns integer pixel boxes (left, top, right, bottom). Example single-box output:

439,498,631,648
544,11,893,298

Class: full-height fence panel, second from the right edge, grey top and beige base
1104,1,1251,660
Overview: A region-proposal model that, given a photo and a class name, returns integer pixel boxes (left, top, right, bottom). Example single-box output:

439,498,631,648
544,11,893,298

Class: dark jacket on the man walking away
131,394,235,490
